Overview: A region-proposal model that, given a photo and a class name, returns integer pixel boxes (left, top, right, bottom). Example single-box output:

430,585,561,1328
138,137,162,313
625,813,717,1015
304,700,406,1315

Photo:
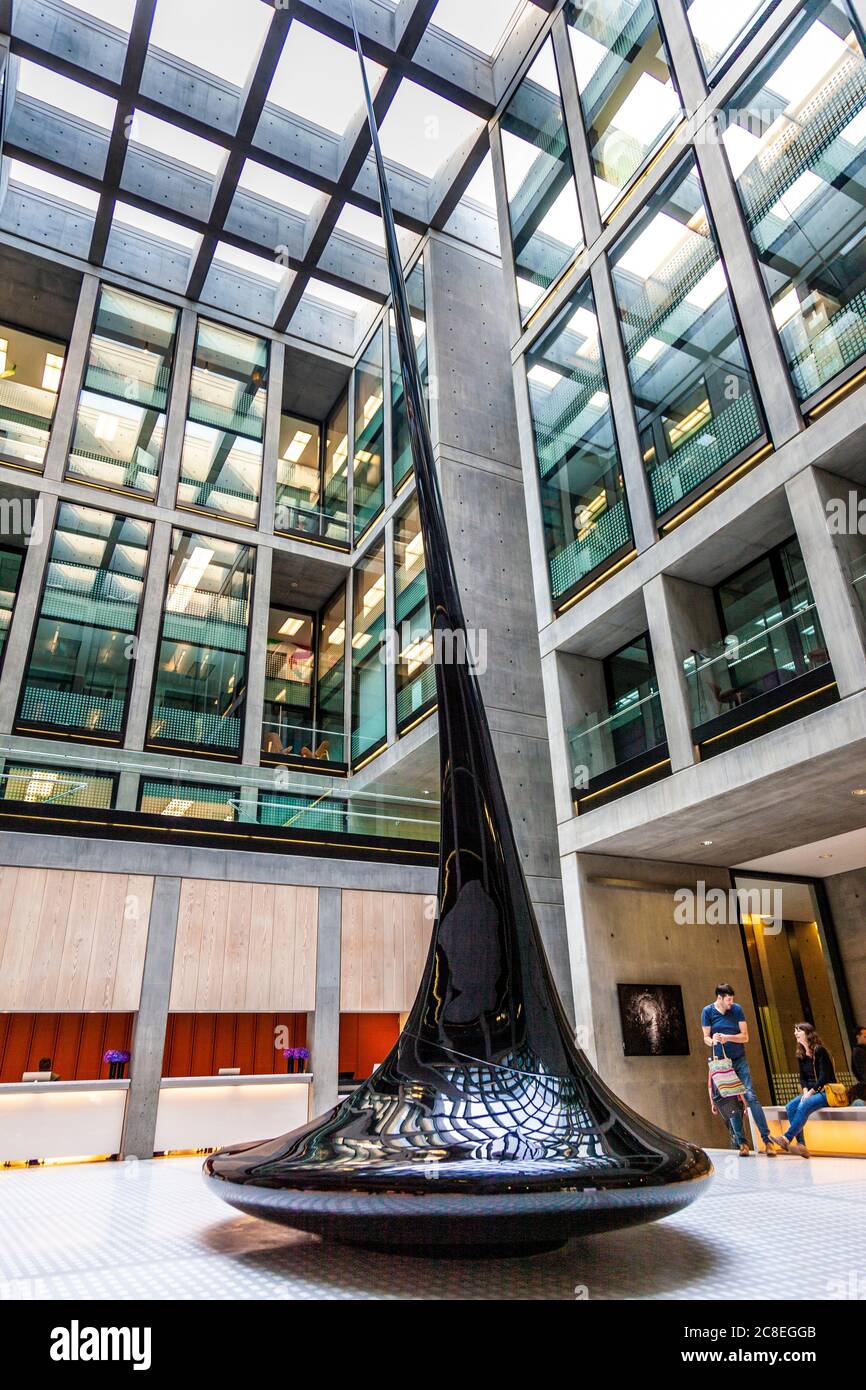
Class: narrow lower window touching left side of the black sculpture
393,498,436,728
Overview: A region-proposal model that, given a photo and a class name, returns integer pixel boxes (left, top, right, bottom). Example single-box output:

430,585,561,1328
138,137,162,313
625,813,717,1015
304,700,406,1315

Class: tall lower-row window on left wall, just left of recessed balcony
149,531,254,755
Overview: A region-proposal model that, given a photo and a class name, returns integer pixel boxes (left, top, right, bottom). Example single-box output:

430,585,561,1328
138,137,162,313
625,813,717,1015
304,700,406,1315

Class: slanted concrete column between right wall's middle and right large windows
695,125,805,448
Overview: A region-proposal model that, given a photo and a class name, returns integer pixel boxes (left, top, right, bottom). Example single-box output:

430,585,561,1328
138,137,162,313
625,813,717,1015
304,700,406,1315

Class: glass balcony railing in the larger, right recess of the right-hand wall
683,602,833,742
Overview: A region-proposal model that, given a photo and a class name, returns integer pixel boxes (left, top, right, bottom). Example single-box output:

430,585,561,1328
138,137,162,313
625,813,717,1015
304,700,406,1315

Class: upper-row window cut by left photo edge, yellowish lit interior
0,322,67,473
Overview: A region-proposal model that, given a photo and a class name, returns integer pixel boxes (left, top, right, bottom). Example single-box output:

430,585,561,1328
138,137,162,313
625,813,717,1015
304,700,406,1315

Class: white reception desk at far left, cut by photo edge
0,1080,129,1163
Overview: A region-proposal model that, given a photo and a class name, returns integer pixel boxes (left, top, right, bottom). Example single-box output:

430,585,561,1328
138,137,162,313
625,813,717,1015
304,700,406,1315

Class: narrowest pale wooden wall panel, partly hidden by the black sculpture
339,890,432,1013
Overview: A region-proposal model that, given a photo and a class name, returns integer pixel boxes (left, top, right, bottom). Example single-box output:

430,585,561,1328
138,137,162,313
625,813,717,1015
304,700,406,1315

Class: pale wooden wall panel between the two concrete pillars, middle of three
170,878,318,1011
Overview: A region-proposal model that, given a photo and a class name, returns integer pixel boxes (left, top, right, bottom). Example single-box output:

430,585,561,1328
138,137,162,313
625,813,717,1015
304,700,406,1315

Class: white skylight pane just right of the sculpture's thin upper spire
379,78,484,178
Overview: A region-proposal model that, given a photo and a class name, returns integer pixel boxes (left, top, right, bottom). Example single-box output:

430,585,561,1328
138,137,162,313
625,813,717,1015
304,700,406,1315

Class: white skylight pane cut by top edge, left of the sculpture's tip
150,0,274,88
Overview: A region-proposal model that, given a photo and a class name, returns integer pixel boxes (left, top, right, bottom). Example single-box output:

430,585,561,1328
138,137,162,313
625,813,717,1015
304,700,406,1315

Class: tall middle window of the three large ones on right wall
610,157,763,516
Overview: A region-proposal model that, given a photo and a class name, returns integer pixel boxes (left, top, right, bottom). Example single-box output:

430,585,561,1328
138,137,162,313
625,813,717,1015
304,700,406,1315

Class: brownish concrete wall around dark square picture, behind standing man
567,855,770,1147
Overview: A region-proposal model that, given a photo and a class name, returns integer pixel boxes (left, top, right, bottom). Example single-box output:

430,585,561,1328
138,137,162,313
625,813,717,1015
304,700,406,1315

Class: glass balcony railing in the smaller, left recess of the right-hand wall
569,681,667,803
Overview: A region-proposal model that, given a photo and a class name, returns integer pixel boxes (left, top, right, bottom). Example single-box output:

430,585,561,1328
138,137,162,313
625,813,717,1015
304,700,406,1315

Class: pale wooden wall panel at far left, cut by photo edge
0,869,153,1013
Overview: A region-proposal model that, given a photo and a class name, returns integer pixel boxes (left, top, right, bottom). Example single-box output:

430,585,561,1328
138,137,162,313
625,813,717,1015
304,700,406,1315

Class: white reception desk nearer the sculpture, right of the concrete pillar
153,1073,313,1154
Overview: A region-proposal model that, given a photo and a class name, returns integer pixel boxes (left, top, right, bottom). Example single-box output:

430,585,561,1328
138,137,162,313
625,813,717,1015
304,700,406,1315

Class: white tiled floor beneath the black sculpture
0,1151,866,1300
